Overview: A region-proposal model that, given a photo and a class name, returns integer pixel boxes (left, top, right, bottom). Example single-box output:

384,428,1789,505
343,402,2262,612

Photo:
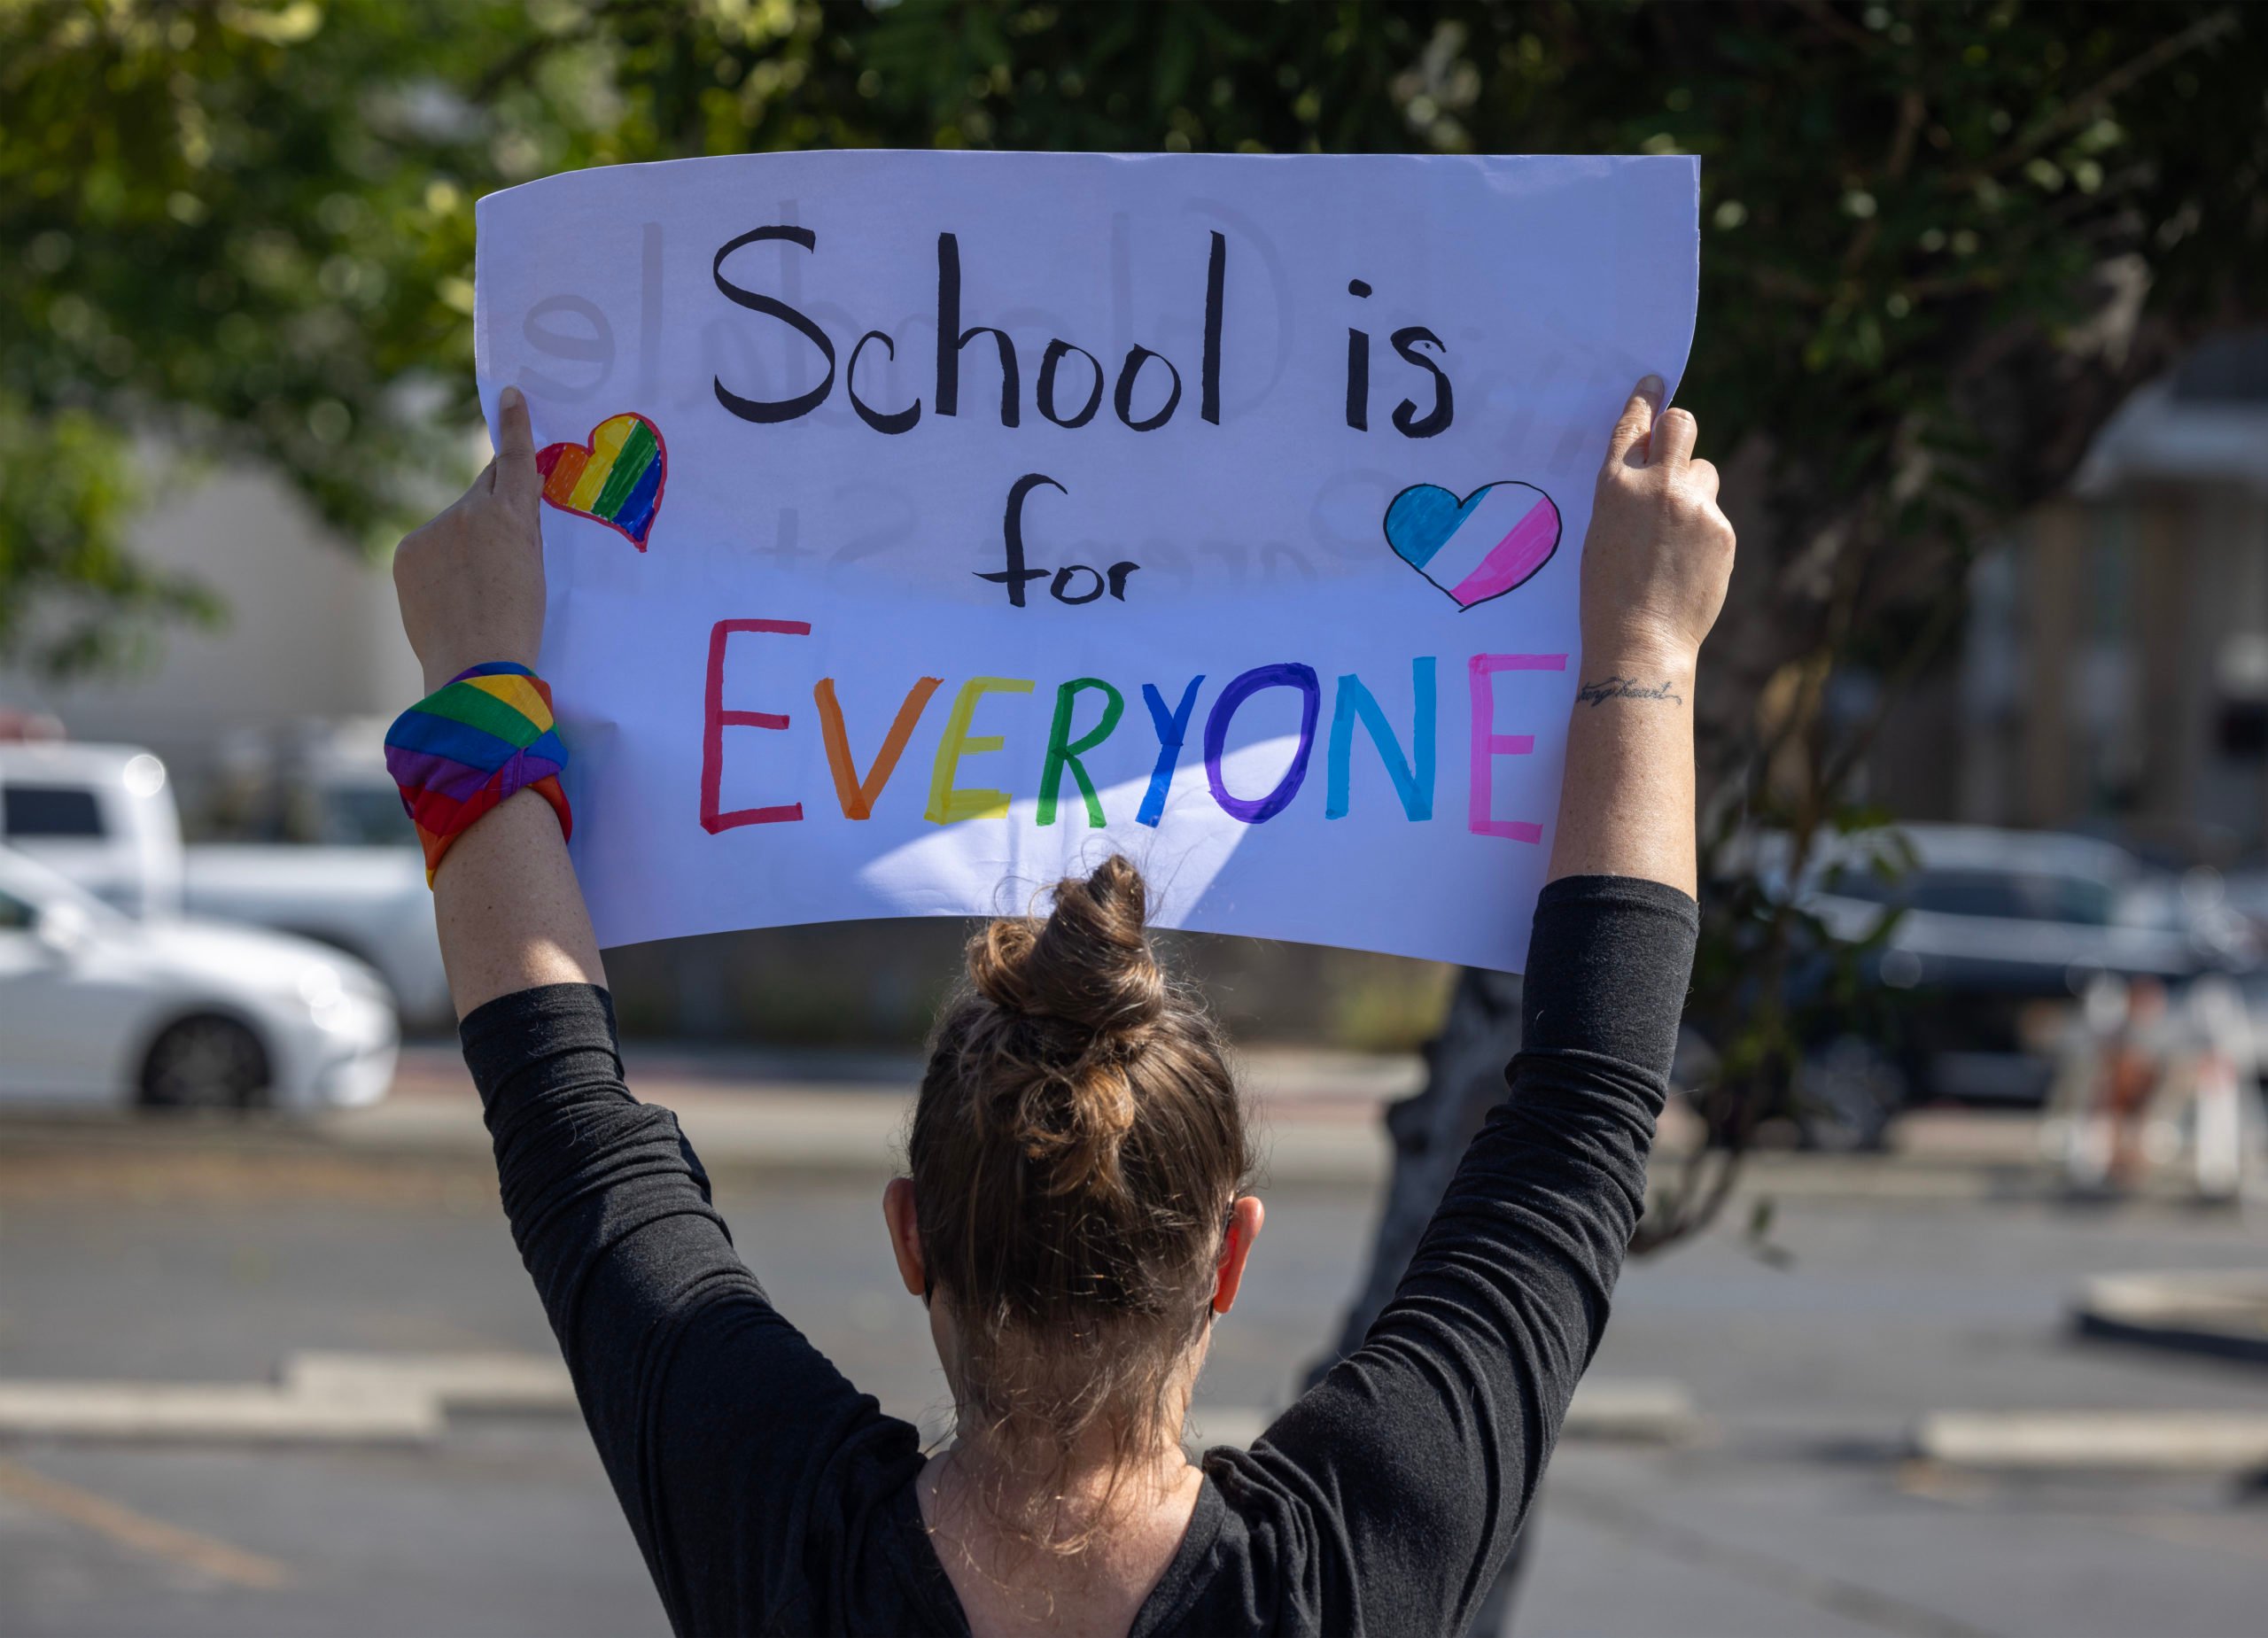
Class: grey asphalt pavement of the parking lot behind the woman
0,1075,2268,1638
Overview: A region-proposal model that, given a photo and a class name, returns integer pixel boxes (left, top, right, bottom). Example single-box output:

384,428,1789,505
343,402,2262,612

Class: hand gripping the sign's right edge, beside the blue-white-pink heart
1583,375,1733,676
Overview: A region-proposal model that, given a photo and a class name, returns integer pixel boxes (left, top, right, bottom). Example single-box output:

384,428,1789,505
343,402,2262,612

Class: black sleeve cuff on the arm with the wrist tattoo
1522,876,1701,1080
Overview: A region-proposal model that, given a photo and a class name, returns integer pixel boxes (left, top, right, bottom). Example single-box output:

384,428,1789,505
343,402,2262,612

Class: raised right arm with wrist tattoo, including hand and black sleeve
1242,379,1733,1634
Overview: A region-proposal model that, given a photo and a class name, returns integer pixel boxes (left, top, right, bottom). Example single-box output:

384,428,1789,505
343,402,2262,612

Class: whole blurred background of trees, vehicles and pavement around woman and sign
0,0,2268,1638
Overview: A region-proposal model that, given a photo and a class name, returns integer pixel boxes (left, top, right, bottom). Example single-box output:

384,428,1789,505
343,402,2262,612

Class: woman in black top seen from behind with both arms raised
394,377,1733,1638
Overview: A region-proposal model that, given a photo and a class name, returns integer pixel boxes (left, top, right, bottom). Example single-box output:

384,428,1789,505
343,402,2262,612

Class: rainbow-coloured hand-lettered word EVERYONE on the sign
701,619,1567,842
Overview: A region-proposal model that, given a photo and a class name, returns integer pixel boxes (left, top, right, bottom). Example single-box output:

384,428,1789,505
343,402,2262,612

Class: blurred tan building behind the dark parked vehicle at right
1941,336,2268,865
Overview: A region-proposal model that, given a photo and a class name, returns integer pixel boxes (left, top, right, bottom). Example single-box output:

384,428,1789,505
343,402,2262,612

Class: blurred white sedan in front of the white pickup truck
0,849,400,1112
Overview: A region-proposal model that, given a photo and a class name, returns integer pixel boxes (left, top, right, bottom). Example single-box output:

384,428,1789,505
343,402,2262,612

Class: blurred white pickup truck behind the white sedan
0,741,451,1028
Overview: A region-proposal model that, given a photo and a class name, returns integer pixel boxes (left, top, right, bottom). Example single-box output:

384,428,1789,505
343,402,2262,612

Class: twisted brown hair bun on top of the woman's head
968,853,1166,1041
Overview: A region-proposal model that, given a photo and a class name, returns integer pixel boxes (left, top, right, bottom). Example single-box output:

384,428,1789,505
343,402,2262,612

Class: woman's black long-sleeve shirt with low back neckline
462,876,1697,1638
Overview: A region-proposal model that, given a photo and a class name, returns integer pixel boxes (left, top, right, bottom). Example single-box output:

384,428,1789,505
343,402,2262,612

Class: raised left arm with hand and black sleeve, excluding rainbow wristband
394,388,893,1631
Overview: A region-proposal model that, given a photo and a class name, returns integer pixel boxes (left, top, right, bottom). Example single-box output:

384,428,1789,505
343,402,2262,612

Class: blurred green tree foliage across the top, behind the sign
0,0,2268,1234
